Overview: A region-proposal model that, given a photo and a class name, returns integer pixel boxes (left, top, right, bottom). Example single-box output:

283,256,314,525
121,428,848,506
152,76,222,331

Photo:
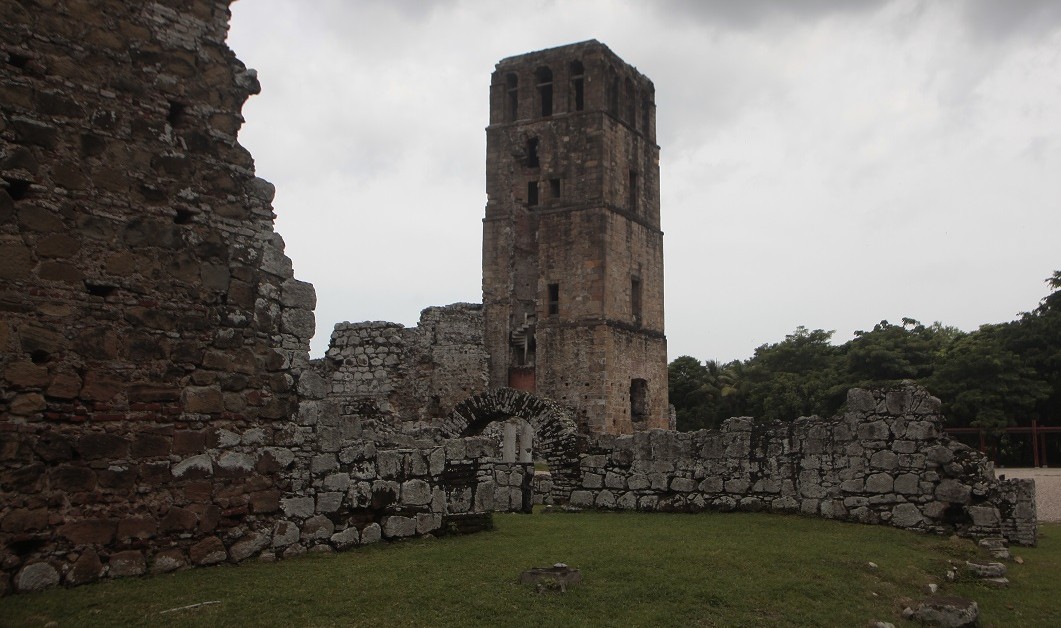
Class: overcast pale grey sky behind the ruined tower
229,0,1061,361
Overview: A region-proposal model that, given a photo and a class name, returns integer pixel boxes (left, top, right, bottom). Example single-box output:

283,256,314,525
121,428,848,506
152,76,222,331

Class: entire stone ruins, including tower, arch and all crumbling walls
0,0,1036,594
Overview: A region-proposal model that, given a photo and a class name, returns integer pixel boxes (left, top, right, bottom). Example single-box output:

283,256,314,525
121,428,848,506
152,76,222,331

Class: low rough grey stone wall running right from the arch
571,386,1036,545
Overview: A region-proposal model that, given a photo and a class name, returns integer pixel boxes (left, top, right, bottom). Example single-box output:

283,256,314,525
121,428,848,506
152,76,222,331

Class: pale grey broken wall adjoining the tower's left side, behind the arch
318,303,488,431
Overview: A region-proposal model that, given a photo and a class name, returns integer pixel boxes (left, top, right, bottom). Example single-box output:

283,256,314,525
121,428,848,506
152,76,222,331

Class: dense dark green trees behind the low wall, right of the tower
669,271,1061,430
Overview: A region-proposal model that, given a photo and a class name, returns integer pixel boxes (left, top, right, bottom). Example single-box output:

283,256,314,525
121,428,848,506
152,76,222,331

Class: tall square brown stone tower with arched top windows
483,40,668,434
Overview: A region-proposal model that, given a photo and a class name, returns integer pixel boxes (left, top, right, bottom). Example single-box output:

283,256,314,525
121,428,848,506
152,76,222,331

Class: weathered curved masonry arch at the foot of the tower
439,388,578,502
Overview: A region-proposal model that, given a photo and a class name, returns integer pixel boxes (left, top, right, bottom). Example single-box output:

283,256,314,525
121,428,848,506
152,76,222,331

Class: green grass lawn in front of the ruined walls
6,513,1061,627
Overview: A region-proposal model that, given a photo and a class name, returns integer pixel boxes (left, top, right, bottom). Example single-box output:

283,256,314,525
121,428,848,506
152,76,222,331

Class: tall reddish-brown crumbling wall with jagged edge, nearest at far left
0,0,314,593
